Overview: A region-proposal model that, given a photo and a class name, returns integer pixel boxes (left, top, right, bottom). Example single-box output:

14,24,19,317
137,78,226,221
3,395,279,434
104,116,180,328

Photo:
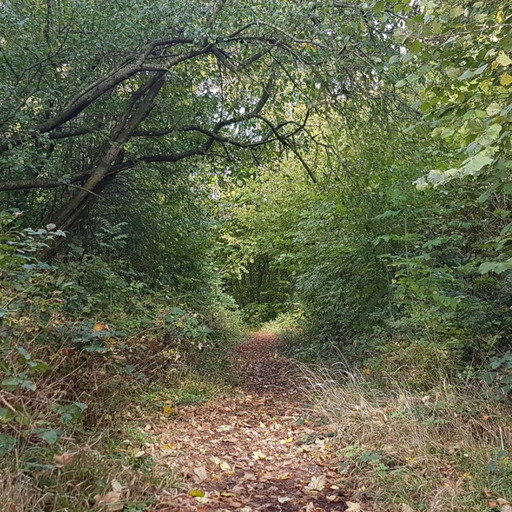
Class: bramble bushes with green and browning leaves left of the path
0,209,240,460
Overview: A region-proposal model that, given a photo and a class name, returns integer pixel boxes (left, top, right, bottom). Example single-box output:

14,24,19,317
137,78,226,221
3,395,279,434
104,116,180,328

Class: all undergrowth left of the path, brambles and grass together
0,214,244,512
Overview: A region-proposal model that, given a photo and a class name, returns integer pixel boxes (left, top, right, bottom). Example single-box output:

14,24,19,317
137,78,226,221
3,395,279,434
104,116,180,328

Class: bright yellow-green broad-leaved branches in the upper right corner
392,0,512,273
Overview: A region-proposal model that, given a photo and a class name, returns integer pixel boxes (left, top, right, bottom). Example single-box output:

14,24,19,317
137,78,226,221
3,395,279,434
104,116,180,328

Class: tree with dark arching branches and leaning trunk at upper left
0,0,395,241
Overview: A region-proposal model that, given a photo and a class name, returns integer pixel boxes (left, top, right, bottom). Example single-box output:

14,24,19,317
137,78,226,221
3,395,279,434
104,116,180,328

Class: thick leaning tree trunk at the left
48,73,165,248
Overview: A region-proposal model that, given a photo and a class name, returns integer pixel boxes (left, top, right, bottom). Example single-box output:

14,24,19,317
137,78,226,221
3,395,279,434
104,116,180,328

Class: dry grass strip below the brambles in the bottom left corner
0,429,182,512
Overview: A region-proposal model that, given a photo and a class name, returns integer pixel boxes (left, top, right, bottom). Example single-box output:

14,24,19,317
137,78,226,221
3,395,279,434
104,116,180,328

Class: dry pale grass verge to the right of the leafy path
304,368,512,512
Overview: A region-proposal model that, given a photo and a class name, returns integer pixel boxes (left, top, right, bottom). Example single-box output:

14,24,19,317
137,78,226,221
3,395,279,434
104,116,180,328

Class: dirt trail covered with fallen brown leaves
150,332,346,512
